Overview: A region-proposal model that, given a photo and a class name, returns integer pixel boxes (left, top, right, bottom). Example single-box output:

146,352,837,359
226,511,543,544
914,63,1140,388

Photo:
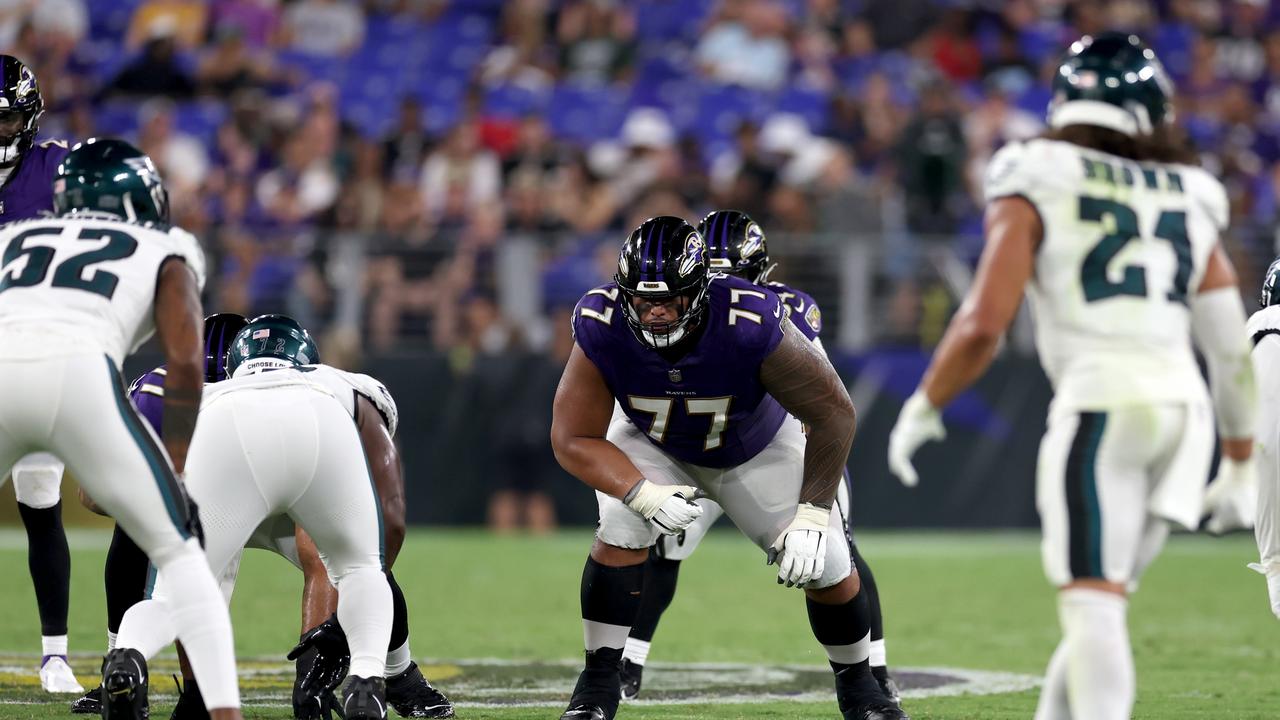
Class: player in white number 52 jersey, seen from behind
0,140,239,719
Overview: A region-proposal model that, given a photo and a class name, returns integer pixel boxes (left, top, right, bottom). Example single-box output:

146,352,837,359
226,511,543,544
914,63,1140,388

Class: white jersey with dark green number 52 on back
0,217,205,366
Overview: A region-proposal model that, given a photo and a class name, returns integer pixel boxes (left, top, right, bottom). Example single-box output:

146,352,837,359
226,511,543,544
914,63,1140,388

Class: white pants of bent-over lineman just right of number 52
120,380,392,678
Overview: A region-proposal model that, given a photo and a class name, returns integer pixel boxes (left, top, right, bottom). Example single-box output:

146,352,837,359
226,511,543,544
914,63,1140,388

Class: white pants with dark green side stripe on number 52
0,353,239,708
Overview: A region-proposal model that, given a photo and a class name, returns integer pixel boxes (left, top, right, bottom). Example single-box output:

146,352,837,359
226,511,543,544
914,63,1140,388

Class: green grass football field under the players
0,530,1280,720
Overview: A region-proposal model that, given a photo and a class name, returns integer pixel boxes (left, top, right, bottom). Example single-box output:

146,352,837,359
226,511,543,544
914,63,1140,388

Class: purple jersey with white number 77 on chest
573,275,787,468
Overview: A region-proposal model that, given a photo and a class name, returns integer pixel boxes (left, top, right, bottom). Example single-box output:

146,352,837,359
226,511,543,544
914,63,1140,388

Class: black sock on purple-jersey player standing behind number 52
18,501,72,637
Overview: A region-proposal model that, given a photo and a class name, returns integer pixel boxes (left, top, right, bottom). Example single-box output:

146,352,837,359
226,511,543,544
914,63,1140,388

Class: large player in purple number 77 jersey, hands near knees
552,217,906,720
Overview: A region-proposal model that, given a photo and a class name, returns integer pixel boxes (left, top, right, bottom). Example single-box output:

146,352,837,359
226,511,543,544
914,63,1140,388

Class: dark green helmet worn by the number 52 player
54,138,169,223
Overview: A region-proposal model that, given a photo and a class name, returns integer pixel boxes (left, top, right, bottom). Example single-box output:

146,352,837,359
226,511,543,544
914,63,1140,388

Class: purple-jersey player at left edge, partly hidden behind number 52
0,55,84,693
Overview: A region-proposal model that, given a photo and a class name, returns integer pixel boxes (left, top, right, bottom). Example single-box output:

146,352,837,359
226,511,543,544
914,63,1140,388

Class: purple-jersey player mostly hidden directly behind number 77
614,210,899,701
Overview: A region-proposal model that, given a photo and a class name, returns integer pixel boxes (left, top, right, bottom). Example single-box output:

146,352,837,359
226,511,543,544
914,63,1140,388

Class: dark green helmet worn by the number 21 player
1048,32,1174,136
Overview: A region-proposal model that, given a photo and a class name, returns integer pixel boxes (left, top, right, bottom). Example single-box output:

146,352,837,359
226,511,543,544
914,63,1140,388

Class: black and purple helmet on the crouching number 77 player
613,215,710,347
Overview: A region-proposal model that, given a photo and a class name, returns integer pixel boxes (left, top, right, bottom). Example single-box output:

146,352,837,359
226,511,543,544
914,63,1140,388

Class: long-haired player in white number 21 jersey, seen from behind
890,33,1256,720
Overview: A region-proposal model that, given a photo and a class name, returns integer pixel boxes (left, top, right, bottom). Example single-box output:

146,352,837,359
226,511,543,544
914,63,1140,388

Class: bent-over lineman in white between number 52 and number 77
118,315,392,720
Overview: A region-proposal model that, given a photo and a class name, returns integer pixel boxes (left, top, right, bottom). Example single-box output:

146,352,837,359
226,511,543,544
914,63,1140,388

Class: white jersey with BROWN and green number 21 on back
986,140,1228,409
